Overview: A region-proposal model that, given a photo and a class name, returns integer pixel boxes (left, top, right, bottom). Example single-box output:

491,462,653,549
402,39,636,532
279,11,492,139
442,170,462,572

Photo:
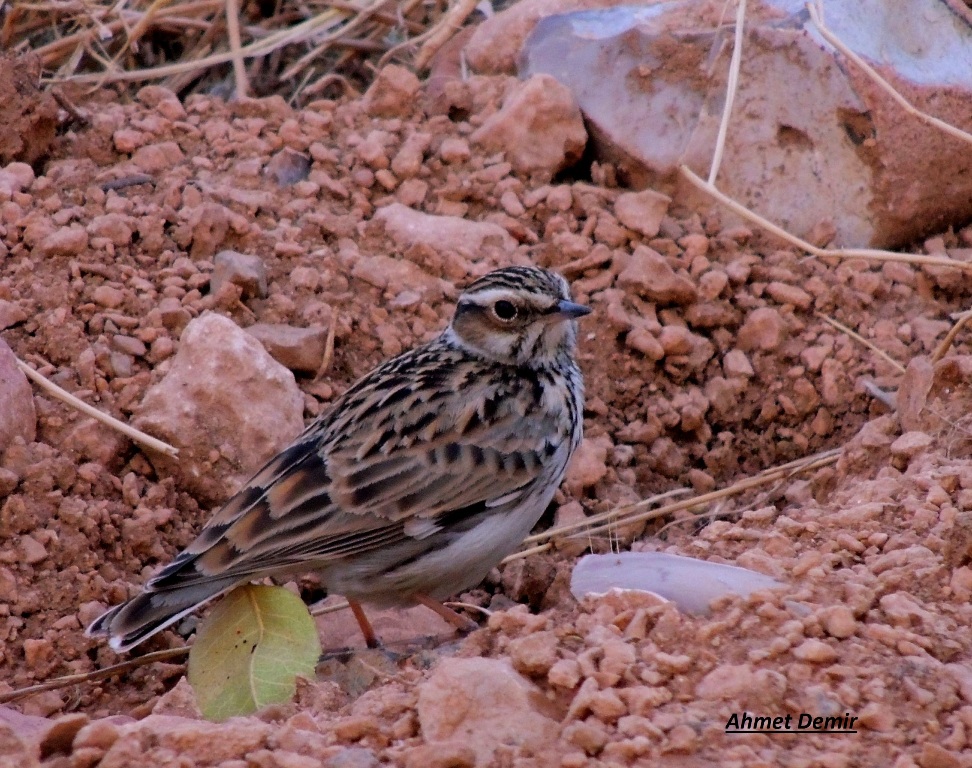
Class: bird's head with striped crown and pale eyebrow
447,267,590,366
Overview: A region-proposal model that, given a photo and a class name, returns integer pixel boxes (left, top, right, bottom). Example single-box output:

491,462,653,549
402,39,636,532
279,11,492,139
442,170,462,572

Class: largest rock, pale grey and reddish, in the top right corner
521,0,972,246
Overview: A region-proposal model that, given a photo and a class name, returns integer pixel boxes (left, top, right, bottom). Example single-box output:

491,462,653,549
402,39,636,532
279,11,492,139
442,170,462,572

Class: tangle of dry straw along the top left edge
0,0,468,100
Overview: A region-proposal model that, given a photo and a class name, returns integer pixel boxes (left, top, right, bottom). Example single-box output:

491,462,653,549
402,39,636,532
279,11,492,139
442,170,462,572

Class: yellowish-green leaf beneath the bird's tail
187,584,321,721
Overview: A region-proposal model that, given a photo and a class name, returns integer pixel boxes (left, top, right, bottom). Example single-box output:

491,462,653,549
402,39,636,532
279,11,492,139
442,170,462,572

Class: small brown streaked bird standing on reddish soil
87,267,590,651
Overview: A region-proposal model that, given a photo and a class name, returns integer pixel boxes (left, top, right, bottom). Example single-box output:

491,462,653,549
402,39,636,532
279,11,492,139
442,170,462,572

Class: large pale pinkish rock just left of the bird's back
133,312,304,502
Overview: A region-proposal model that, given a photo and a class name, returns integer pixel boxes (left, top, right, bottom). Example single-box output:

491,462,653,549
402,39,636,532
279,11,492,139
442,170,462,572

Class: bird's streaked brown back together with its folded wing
147,348,570,589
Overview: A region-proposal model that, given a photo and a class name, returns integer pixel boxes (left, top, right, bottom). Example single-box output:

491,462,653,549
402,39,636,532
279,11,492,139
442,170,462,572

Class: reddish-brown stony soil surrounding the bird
0,52,972,768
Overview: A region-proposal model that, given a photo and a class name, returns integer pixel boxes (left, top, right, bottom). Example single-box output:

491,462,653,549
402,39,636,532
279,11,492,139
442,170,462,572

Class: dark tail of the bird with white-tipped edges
85,576,240,652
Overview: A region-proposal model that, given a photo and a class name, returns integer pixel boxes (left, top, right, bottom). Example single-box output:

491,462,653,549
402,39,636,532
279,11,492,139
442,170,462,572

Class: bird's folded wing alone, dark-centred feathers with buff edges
147,402,558,590
